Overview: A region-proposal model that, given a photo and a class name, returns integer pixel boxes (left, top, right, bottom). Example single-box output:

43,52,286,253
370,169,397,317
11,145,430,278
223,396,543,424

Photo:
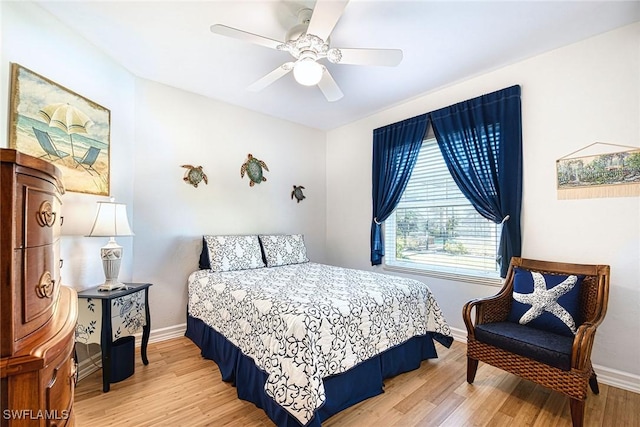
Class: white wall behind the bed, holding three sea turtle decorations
134,80,326,329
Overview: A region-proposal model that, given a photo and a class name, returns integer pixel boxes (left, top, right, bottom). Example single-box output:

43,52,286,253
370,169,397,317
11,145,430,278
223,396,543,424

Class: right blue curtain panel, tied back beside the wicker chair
429,86,522,277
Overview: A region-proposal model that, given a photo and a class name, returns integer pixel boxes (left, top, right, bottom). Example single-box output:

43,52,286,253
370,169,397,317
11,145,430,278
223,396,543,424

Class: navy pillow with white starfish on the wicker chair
509,268,584,336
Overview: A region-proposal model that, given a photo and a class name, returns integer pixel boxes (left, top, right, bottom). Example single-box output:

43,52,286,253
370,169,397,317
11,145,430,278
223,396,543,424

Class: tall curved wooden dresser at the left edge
0,149,78,427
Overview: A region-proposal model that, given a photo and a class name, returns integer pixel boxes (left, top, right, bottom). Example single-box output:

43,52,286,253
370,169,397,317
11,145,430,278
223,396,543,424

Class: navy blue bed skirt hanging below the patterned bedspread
185,316,453,427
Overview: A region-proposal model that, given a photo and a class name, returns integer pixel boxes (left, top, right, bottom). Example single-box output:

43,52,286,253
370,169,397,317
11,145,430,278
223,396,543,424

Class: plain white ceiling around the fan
36,0,640,130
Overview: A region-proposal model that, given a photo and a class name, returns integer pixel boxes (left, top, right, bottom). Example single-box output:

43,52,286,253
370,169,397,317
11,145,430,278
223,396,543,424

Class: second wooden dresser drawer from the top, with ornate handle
14,242,60,341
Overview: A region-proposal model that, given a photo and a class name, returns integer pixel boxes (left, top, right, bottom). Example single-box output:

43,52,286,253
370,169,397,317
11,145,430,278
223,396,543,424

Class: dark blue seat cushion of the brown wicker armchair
475,322,573,371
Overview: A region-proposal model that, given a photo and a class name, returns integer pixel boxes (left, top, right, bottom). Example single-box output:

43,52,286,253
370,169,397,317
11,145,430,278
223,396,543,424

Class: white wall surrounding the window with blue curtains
327,24,640,380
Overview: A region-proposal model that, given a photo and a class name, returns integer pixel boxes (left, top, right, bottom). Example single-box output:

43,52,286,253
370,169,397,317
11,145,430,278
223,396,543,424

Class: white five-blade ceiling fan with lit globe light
211,0,402,101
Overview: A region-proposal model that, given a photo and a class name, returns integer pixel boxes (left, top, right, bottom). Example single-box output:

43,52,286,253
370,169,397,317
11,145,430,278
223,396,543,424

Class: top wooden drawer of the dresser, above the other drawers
15,175,62,248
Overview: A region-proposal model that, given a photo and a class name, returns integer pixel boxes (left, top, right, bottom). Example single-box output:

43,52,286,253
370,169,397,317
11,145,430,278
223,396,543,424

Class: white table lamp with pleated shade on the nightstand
88,198,133,291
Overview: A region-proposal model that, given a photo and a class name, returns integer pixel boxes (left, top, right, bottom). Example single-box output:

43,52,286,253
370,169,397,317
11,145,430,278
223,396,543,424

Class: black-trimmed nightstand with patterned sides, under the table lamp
76,283,151,392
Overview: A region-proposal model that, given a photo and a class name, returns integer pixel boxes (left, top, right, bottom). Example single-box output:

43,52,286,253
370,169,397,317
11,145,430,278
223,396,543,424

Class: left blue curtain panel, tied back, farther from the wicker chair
371,114,429,265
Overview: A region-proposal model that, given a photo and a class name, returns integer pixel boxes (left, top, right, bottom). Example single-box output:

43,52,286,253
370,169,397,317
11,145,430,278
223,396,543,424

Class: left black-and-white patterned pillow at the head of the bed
204,235,264,271
